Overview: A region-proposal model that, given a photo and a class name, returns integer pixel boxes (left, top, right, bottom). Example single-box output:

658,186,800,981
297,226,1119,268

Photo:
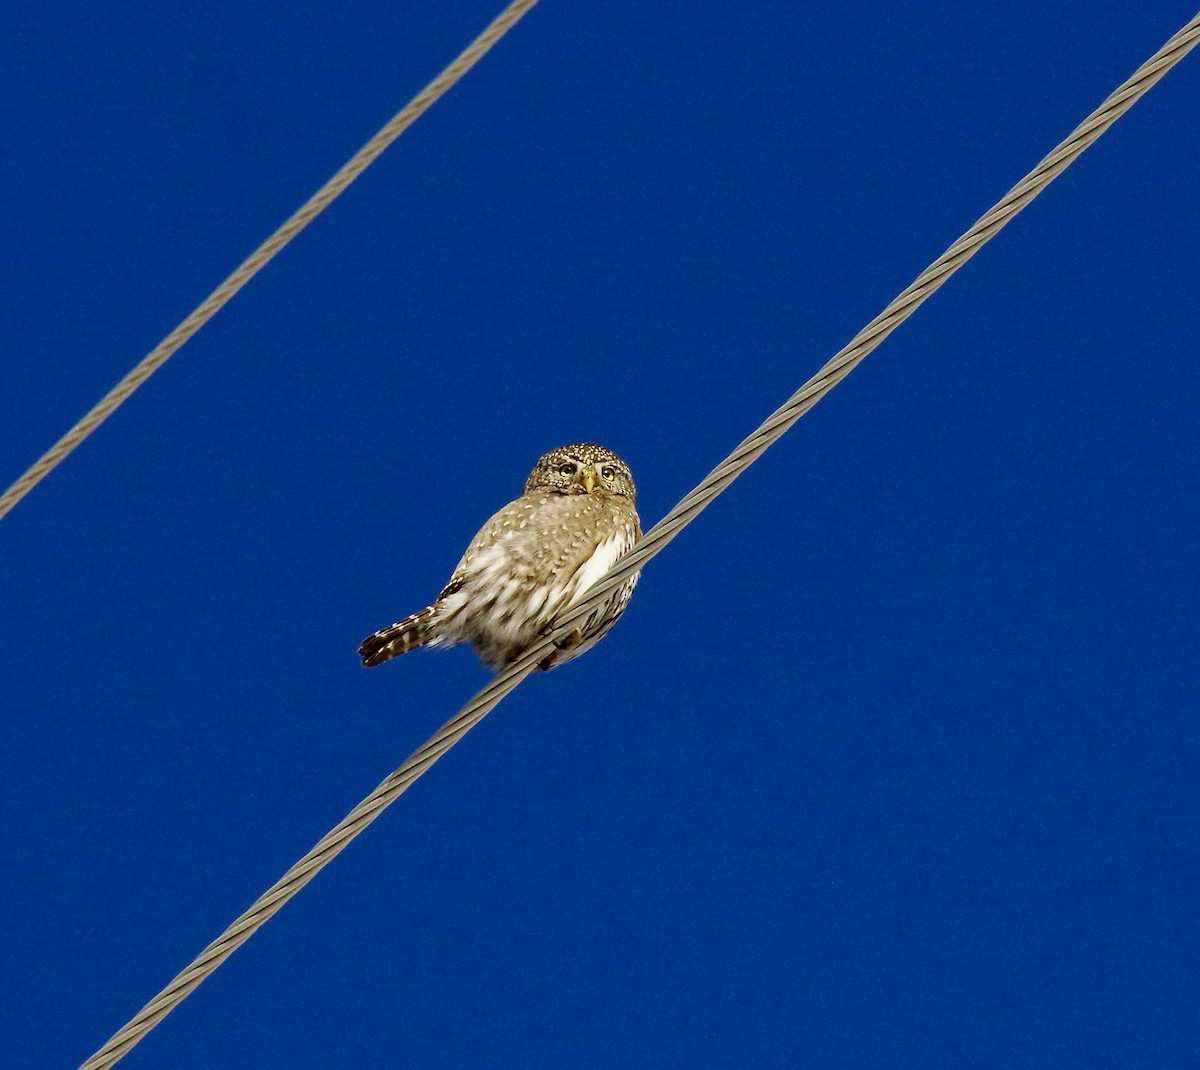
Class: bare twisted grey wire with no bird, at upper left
0,0,538,518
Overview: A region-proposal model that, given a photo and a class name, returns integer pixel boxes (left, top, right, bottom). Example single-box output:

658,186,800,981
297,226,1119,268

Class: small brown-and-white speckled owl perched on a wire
359,443,642,672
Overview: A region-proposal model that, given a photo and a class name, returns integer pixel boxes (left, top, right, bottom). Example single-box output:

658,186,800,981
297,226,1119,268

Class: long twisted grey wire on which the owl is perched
82,13,1200,1070
